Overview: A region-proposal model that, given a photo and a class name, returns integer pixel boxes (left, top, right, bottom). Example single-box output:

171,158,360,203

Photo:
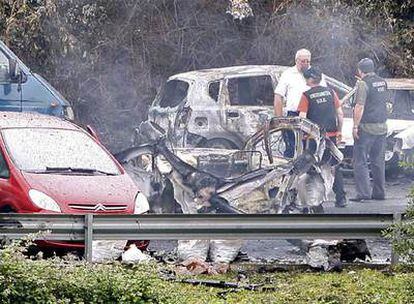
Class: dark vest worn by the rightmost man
361,74,388,123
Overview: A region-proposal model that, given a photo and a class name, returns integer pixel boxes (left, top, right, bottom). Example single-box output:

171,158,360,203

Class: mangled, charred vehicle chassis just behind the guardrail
116,117,342,213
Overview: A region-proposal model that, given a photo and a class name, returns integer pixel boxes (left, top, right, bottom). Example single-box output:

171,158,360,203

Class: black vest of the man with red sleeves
304,86,338,132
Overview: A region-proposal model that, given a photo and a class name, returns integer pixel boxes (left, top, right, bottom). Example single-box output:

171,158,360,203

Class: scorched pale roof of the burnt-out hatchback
169,65,289,81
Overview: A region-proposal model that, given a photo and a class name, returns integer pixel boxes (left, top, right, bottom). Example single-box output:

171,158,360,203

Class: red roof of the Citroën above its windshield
0,112,79,130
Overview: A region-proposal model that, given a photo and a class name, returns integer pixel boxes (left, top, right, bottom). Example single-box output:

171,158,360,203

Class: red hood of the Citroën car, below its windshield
22,172,138,213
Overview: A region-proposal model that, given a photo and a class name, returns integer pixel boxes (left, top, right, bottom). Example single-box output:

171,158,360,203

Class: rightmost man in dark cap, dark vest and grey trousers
350,58,388,202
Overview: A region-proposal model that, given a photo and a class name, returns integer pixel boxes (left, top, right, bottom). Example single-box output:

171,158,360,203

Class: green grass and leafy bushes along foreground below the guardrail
0,239,414,304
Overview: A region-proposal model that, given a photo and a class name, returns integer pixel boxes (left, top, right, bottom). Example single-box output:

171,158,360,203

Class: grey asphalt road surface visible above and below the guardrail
149,177,414,263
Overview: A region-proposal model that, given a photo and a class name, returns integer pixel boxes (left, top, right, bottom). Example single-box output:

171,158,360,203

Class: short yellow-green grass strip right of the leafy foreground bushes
163,269,414,304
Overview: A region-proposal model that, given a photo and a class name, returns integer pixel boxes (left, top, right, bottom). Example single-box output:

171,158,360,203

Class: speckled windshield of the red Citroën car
2,128,120,175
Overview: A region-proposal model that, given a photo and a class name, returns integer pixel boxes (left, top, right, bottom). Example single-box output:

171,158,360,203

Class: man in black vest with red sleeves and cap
298,67,346,207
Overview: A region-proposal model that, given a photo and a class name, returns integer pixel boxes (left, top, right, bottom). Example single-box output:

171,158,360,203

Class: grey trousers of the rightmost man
353,130,386,199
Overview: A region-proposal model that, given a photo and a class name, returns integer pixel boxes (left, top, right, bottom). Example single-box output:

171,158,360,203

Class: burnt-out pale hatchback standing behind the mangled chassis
134,65,352,149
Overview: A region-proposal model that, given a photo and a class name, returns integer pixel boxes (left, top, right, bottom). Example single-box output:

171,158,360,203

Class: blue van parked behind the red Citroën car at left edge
0,41,74,120
